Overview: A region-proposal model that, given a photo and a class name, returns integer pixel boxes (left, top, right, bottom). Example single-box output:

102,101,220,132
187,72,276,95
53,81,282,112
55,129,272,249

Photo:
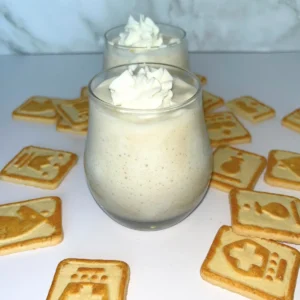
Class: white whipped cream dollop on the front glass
109,65,173,109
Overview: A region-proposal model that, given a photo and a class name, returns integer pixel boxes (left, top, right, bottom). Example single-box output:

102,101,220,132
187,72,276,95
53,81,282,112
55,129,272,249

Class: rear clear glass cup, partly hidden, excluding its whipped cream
103,23,189,70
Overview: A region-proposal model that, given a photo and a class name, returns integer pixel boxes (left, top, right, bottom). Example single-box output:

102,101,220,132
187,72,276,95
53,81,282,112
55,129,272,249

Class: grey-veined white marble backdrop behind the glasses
0,0,300,54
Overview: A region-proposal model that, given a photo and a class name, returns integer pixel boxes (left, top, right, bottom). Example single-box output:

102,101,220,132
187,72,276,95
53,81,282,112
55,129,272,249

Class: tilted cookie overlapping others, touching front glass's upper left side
56,98,89,130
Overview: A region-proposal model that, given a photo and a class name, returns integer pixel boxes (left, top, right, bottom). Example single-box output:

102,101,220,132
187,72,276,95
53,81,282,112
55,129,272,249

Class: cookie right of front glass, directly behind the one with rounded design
205,112,251,147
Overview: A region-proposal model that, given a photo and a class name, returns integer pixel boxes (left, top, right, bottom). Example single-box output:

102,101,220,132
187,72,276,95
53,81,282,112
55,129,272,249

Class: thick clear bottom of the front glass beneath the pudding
88,180,209,231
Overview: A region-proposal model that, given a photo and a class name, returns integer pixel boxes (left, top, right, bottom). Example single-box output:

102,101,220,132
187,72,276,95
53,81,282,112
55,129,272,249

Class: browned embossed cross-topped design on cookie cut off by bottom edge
59,267,109,300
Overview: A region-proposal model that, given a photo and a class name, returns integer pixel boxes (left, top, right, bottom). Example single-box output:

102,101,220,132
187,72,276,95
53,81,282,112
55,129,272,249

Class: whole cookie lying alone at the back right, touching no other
226,96,276,123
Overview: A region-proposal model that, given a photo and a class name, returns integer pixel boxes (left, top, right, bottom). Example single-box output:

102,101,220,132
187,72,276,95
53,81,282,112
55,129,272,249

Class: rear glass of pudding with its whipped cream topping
103,16,189,70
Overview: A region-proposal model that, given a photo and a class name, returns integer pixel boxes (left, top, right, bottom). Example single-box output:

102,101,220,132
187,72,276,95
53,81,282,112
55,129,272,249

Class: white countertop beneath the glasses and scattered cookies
0,53,300,300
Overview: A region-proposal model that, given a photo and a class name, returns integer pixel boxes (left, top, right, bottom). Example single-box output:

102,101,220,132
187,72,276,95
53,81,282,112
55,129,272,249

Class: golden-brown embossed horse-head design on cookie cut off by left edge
0,206,47,241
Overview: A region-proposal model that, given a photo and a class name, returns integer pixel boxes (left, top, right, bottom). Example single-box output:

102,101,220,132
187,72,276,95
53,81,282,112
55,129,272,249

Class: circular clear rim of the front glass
88,62,202,115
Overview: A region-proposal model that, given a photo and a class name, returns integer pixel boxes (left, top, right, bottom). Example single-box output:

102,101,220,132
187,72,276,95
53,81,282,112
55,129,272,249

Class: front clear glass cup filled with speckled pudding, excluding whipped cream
84,64,212,230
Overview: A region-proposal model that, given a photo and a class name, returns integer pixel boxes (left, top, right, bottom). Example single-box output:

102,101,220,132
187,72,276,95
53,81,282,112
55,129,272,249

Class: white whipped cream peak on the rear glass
118,15,163,48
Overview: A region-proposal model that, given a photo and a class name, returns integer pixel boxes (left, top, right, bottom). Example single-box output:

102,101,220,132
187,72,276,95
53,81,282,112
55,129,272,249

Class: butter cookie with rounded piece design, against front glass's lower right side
211,146,267,192
